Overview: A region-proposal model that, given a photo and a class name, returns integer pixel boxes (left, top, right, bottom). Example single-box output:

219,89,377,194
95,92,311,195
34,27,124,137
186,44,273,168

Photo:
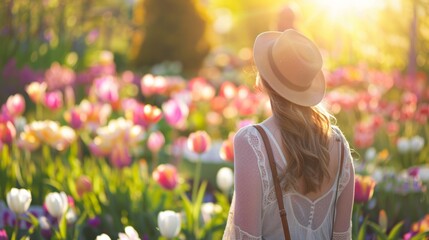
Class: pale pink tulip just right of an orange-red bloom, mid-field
162,99,189,129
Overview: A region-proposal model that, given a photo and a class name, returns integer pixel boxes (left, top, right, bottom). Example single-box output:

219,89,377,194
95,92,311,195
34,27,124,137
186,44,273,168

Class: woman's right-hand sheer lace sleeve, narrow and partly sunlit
334,126,355,237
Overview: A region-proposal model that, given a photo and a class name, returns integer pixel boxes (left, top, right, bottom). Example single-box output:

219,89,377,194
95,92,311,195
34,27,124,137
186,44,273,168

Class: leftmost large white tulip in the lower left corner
6,188,31,214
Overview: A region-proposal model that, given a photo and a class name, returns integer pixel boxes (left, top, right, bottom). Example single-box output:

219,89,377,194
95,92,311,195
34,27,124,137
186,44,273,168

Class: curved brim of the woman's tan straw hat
253,31,326,106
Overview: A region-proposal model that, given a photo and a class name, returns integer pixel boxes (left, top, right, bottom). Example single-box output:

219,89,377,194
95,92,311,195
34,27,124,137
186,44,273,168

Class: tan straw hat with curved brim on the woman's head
253,29,325,106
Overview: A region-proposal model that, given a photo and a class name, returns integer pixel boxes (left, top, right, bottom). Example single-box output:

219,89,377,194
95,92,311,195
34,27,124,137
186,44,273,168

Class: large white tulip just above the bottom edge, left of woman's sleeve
158,210,181,238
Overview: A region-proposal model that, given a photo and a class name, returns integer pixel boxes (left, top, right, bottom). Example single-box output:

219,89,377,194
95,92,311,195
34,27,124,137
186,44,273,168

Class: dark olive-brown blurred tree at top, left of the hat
130,0,212,75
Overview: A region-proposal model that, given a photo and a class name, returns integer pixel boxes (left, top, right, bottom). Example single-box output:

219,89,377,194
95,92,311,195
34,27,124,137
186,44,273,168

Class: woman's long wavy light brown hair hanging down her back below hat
257,76,333,194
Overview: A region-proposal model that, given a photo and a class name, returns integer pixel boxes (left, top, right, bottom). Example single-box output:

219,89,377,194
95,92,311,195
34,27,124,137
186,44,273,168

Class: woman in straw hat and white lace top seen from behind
224,29,354,239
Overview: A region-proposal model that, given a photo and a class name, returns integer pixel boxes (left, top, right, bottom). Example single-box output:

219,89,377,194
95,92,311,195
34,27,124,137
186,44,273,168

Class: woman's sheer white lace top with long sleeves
223,119,354,240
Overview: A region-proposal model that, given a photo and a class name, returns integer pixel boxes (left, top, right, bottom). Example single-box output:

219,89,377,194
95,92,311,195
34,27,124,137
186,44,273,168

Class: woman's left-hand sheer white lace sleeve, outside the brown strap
223,126,262,240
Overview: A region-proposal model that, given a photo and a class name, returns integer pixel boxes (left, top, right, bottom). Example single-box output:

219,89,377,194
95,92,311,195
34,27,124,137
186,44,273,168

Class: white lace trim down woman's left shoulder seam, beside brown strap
245,128,270,208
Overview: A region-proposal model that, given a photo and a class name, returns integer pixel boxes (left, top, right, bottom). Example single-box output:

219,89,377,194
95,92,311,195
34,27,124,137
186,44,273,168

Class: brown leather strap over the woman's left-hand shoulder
255,125,290,240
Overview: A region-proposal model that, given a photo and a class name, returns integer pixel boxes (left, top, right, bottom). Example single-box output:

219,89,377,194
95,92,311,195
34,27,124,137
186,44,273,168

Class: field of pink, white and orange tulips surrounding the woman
0,56,429,239
